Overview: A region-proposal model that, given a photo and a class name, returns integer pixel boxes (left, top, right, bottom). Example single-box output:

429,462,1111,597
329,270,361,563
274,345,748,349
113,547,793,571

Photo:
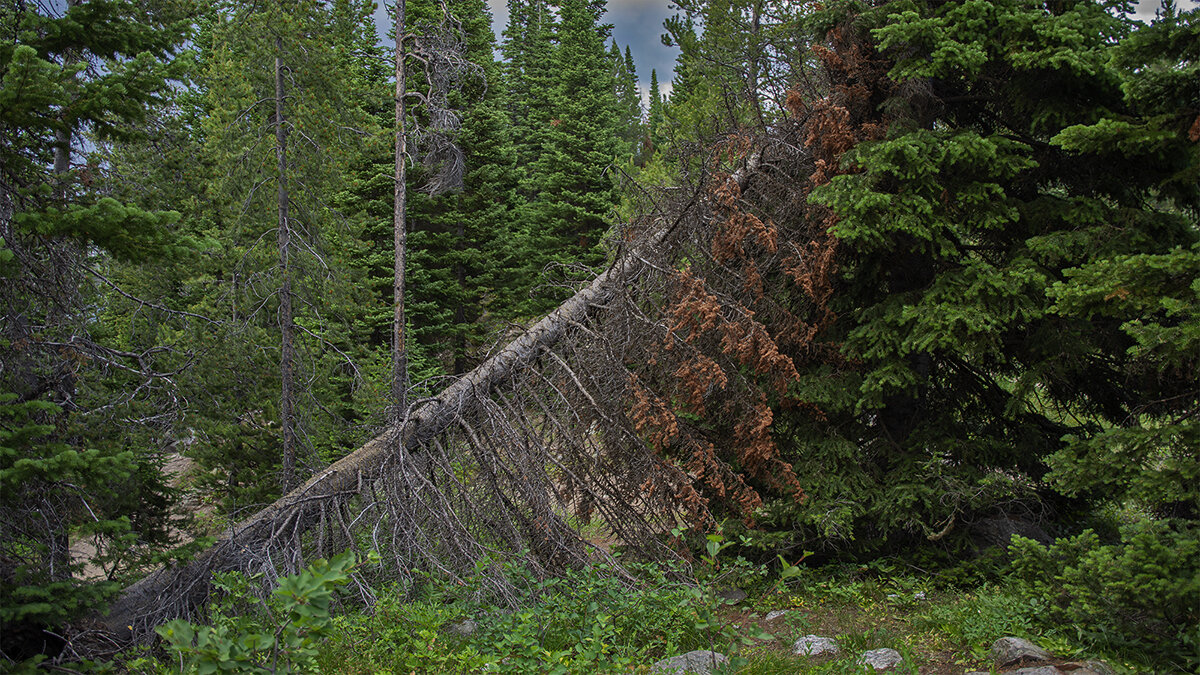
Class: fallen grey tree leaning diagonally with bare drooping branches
98,151,762,644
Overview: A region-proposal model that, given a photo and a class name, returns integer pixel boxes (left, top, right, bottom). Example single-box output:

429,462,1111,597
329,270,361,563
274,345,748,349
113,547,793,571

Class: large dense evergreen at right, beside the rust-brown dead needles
748,1,1200,554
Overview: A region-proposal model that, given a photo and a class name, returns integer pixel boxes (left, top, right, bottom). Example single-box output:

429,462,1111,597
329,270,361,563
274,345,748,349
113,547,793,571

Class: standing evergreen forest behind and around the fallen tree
0,0,1200,658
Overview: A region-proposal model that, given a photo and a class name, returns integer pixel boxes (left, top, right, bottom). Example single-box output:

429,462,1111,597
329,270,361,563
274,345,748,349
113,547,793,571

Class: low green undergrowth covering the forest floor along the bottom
30,534,1192,675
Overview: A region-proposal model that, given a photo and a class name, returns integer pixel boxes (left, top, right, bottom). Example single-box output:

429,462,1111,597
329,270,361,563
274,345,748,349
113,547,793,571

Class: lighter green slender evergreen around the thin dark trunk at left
205,2,371,489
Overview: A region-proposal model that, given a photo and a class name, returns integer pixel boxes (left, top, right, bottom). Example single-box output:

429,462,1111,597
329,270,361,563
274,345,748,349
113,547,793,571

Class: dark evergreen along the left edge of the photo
0,1,186,643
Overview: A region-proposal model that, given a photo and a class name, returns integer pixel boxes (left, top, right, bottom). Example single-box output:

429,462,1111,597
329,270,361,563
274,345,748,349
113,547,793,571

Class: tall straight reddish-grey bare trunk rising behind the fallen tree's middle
391,0,408,418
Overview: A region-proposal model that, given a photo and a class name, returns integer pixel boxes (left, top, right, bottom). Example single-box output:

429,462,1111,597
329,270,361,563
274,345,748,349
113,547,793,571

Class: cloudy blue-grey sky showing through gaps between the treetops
376,0,1180,106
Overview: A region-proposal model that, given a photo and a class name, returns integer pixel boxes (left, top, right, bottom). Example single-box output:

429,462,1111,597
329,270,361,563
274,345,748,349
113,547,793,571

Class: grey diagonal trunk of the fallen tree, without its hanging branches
97,154,761,643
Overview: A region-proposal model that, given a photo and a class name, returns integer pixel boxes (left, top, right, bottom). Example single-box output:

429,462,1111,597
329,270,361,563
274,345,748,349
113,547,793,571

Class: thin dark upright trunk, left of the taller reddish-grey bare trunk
275,37,296,492
